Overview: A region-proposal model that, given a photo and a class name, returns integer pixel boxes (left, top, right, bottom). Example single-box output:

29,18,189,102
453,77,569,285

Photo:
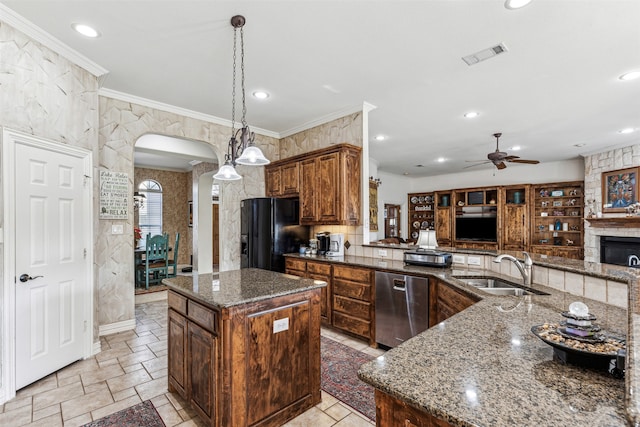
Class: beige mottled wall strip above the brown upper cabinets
280,112,368,157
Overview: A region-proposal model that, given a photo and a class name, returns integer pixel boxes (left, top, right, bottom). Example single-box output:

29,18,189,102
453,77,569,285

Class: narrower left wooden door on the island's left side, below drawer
168,310,187,399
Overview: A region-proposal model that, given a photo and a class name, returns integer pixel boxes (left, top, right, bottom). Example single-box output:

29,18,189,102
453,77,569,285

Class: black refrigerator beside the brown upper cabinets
240,197,309,272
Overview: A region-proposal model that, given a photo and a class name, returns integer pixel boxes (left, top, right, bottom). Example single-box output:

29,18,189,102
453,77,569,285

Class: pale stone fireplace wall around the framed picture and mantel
584,144,640,262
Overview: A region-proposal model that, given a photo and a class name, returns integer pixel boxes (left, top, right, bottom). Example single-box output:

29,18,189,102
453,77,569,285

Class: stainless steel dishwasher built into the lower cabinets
376,271,429,347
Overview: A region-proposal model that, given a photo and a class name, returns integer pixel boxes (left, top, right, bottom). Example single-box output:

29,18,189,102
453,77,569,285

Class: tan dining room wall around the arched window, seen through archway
133,168,191,264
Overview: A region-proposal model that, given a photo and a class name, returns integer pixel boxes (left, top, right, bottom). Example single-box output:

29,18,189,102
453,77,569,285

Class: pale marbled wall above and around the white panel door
0,21,100,388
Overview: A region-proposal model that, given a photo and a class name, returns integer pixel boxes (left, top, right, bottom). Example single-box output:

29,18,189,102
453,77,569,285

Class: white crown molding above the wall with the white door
0,3,109,77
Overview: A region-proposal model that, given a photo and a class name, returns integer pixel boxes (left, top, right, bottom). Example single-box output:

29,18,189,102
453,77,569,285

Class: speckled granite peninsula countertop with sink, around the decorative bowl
287,254,640,426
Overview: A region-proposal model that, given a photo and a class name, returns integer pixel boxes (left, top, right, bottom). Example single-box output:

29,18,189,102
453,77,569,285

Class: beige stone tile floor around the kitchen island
0,292,383,427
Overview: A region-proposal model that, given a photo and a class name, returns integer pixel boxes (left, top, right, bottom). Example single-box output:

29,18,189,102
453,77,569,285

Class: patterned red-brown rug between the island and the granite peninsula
320,337,376,421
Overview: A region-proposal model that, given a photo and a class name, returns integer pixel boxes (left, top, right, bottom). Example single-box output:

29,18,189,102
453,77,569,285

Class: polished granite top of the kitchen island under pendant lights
162,268,327,309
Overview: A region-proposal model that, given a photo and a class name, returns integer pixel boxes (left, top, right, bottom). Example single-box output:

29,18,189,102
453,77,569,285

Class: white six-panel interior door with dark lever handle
15,143,91,389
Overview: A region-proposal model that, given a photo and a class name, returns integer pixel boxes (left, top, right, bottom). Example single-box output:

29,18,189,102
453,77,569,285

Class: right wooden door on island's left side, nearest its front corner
187,322,218,425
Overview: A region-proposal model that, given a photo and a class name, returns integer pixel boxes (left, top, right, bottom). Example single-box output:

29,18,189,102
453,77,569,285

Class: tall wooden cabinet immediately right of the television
498,185,530,251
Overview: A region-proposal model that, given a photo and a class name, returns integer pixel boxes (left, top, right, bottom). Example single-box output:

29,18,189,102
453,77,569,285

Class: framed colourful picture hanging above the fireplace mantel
602,168,638,212
